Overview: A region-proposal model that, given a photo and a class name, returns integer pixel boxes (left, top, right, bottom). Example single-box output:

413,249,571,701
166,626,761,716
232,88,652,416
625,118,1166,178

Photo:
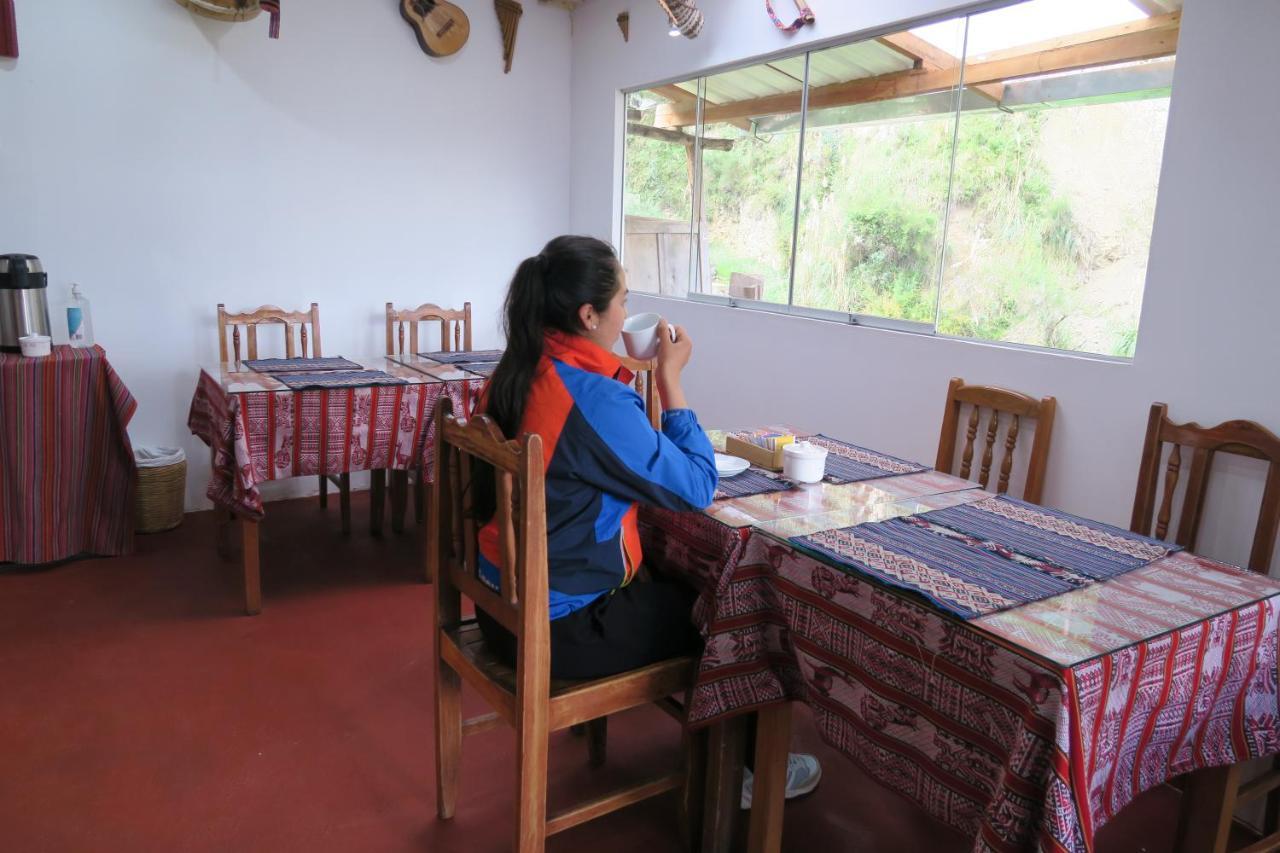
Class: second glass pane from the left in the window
695,66,804,305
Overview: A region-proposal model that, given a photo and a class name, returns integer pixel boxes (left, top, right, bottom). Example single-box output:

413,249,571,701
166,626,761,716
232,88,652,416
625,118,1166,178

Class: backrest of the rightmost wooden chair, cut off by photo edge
1129,402,1280,574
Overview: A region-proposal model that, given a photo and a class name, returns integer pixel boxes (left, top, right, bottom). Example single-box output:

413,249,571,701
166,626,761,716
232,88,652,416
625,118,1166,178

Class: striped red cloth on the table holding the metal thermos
0,346,137,564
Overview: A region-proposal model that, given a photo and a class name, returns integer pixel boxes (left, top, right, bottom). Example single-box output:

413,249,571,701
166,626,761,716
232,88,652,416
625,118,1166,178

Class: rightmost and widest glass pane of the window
938,0,1175,356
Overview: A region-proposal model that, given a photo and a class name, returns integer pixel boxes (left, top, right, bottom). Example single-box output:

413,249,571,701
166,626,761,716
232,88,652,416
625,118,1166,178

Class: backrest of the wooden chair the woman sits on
428,397,550,679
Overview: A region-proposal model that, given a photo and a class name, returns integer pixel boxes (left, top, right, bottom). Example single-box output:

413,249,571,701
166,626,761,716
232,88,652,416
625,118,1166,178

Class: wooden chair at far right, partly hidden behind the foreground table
1129,402,1280,853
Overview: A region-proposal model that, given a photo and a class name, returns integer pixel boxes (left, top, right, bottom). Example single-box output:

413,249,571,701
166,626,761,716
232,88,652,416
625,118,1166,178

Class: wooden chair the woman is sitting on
428,400,696,853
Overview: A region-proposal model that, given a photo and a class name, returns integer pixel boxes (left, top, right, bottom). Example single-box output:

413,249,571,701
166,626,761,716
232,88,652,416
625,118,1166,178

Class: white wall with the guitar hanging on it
0,0,570,508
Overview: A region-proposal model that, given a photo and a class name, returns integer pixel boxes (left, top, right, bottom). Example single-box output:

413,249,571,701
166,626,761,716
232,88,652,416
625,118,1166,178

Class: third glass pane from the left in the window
794,19,964,325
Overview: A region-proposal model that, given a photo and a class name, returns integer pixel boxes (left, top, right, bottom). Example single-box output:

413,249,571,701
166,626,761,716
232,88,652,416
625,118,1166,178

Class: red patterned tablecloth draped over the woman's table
645,502,1280,850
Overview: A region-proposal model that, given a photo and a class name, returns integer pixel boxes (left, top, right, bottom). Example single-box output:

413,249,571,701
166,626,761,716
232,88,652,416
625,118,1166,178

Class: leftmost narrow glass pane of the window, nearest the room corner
622,81,696,296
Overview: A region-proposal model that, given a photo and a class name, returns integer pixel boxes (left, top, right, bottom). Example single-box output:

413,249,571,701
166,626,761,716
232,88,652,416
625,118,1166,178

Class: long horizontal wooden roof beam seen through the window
654,13,1179,127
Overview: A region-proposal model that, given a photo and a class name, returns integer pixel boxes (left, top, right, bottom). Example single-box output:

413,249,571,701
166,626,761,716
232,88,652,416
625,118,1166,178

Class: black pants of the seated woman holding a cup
476,571,703,679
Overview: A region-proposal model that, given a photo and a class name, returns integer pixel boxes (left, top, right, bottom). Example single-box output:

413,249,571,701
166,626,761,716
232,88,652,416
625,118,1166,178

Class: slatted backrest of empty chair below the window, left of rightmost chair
934,378,1057,503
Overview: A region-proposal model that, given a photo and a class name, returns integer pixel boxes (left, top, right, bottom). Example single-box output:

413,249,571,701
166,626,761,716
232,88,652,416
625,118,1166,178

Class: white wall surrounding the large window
572,0,1280,571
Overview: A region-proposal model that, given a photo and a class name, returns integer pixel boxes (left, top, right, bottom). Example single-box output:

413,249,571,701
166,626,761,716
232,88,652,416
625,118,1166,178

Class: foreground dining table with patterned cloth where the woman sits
640,427,1280,853
